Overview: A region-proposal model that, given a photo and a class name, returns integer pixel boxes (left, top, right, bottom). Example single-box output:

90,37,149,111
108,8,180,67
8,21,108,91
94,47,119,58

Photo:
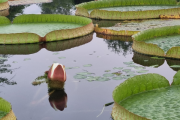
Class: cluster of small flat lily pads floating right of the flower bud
66,61,152,82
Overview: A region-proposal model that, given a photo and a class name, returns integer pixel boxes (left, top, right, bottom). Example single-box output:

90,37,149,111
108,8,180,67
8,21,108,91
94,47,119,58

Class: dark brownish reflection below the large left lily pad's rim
0,33,93,55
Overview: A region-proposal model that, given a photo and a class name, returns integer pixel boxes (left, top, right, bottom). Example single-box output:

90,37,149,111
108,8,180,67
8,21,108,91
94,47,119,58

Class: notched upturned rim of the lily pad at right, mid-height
132,26,180,59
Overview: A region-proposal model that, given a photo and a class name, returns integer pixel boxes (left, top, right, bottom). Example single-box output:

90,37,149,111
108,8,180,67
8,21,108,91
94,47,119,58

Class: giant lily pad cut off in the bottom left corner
0,97,16,120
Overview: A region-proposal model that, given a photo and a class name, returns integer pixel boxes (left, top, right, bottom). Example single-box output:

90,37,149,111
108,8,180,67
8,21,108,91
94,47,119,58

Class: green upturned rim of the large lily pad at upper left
0,14,94,44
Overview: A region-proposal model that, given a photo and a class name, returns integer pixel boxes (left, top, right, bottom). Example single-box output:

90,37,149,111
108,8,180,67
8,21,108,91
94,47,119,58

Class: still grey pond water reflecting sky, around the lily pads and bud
0,0,180,120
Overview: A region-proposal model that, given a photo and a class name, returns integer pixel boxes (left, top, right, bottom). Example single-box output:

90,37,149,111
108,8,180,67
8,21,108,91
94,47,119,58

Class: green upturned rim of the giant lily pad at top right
76,0,180,20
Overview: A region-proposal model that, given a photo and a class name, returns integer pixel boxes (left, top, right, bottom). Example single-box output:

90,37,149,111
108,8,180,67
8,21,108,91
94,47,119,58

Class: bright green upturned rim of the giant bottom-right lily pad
112,71,180,120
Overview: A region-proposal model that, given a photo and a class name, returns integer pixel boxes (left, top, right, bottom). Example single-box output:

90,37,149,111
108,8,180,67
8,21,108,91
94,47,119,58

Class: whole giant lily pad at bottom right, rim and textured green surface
112,71,180,120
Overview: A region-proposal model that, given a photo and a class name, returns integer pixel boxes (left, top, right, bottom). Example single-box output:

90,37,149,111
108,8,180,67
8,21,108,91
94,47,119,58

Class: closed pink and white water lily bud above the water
48,63,66,82
